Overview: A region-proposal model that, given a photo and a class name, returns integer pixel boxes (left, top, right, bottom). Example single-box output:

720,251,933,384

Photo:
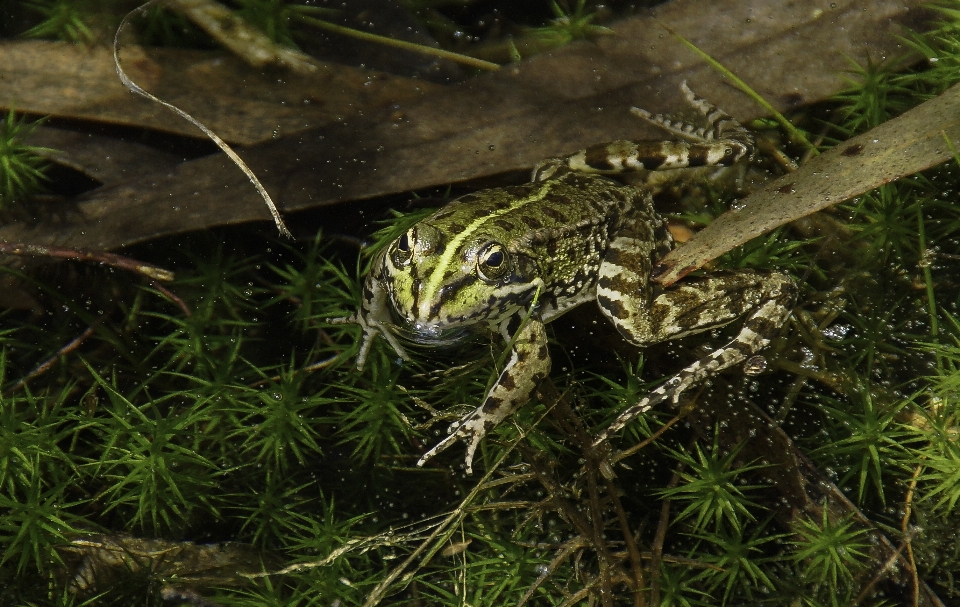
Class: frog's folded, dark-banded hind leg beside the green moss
594,228,797,445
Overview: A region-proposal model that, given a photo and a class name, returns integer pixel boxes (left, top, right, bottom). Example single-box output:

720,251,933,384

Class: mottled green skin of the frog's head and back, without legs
374,173,672,341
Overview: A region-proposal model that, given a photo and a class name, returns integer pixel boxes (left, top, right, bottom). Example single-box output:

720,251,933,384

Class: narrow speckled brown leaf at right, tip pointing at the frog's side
654,85,960,284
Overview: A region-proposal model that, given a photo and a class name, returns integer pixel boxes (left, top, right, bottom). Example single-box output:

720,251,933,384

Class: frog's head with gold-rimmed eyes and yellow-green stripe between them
380,218,541,341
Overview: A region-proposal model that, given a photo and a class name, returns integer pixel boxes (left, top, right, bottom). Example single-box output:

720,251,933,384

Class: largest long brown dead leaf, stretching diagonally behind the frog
0,0,925,249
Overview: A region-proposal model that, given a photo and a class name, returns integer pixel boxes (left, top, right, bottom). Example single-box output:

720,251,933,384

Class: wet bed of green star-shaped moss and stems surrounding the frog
0,0,960,607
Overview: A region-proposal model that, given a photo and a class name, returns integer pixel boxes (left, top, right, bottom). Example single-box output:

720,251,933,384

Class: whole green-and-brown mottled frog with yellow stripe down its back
331,82,797,474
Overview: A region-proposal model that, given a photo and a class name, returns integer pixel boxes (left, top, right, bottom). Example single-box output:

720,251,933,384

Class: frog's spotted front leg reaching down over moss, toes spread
417,317,550,474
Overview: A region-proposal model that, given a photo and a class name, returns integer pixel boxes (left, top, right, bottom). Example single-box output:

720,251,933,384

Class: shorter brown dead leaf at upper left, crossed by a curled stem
0,40,436,145
